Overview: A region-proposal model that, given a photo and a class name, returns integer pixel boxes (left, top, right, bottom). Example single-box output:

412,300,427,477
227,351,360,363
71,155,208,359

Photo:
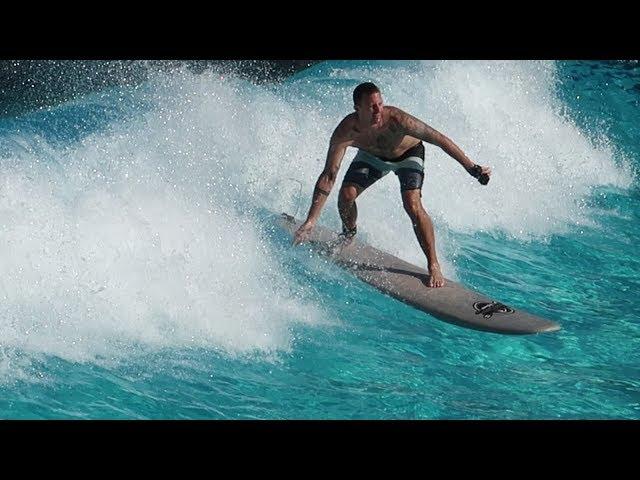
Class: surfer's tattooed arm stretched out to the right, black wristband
396,109,491,185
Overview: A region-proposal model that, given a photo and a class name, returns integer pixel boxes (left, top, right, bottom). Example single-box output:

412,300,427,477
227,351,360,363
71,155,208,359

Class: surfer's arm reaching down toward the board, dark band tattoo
293,127,351,245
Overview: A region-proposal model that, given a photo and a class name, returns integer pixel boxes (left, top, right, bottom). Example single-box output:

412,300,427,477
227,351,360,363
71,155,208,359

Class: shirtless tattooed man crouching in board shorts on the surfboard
293,82,491,287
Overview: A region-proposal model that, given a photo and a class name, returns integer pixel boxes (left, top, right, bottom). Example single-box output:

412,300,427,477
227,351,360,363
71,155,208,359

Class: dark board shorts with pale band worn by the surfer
342,142,424,192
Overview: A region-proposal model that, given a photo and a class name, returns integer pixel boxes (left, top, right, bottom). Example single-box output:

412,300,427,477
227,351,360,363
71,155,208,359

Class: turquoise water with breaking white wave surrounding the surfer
0,61,640,419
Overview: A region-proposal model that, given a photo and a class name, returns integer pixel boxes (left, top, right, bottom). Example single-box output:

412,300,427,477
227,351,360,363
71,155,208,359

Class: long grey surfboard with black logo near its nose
280,213,560,335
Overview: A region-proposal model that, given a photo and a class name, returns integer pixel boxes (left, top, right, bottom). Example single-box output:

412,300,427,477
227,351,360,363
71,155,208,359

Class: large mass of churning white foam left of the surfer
0,71,336,378
